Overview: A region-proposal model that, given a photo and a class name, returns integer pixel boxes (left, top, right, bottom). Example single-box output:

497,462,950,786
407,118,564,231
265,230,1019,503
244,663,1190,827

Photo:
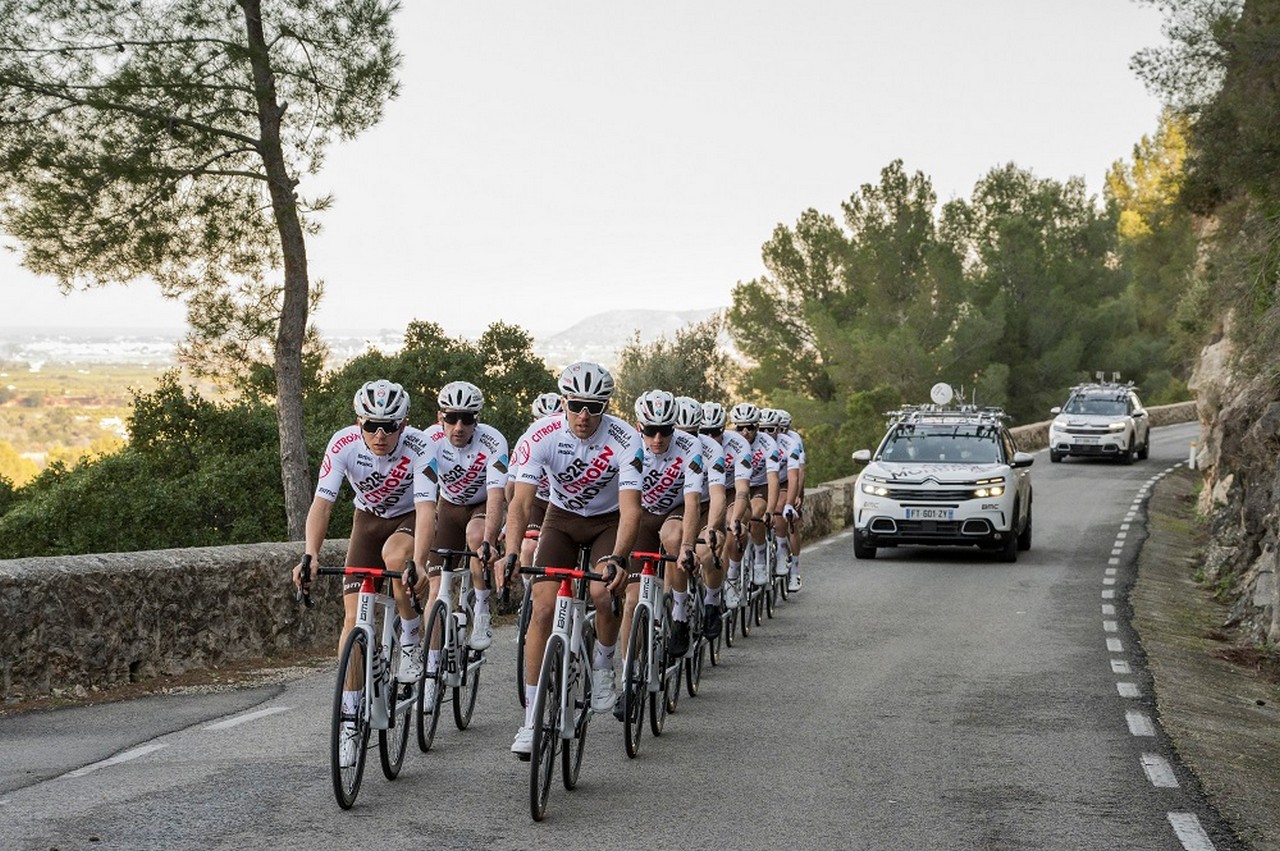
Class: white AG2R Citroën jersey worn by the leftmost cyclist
316,425,438,517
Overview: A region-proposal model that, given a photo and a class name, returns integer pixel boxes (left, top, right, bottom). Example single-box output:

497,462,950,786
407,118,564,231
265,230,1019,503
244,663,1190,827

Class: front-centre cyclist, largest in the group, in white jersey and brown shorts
498,361,644,759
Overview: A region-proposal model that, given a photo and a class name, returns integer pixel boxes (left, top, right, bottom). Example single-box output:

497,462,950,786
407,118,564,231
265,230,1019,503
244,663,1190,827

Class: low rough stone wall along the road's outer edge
0,402,1196,703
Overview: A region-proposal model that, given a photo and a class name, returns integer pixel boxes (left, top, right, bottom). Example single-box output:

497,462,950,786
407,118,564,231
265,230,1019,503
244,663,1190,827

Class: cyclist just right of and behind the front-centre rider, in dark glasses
613,390,703,718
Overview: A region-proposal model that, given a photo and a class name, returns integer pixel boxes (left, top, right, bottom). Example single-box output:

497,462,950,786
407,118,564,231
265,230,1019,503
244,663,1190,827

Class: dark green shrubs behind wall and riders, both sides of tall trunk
0,322,545,558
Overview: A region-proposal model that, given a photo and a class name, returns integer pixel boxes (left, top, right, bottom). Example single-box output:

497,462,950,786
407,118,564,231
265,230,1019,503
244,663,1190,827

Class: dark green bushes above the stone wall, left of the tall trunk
0,374,284,558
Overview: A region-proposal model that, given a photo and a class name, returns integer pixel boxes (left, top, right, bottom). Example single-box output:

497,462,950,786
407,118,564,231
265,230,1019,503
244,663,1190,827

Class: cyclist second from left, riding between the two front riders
426,381,507,652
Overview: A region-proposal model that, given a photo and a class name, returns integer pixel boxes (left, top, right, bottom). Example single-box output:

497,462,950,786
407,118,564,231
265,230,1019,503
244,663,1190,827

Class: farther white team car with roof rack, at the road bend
1048,375,1151,465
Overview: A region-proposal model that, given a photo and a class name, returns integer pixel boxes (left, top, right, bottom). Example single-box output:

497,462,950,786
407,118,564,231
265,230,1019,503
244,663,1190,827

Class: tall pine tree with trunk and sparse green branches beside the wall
0,0,399,539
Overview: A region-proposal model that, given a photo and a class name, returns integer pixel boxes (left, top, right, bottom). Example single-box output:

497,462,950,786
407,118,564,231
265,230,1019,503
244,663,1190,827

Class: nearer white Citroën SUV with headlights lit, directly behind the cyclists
854,406,1034,562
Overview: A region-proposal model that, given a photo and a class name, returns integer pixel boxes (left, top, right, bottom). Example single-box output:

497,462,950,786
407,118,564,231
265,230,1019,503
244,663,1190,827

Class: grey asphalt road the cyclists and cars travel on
0,425,1239,851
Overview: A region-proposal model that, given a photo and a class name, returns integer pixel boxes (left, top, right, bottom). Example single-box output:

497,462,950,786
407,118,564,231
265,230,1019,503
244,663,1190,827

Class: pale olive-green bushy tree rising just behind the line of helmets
613,315,732,420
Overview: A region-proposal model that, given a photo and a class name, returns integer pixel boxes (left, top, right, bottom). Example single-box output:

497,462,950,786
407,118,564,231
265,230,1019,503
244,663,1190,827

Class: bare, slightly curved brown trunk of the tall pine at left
239,0,311,541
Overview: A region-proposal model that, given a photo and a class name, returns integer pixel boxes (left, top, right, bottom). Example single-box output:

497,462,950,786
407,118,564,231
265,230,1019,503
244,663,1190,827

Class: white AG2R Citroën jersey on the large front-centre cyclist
516,413,644,517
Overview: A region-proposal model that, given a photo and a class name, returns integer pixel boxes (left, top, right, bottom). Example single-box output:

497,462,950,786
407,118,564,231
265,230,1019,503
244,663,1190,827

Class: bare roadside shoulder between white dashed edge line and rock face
1129,468,1280,851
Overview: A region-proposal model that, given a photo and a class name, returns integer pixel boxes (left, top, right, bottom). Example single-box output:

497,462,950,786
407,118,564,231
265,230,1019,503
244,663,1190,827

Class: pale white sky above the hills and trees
0,0,1162,334
